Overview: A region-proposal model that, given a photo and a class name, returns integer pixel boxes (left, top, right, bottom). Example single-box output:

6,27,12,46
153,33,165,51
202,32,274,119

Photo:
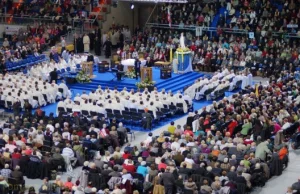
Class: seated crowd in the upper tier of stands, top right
156,0,300,34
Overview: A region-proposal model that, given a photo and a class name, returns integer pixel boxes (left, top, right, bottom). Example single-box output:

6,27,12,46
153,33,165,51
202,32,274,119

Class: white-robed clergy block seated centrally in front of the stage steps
56,88,192,118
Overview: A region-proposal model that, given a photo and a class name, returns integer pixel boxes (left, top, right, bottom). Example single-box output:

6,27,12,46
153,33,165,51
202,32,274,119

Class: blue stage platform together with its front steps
68,68,209,92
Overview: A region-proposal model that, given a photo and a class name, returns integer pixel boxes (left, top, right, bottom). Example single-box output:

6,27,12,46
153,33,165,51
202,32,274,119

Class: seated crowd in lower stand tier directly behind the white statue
109,23,300,76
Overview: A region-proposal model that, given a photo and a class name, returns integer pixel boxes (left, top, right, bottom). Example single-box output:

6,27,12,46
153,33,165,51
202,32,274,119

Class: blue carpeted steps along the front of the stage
68,72,209,93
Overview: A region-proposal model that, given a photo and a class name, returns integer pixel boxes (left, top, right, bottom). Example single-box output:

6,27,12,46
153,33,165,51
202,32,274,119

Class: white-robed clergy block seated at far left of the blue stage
0,74,71,108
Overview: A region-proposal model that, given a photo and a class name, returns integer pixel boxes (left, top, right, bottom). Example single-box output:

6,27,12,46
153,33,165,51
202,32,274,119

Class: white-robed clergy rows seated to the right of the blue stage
185,68,252,100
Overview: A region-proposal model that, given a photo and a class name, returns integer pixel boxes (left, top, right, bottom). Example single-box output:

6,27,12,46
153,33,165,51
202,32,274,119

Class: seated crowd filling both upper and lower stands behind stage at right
101,0,300,76
